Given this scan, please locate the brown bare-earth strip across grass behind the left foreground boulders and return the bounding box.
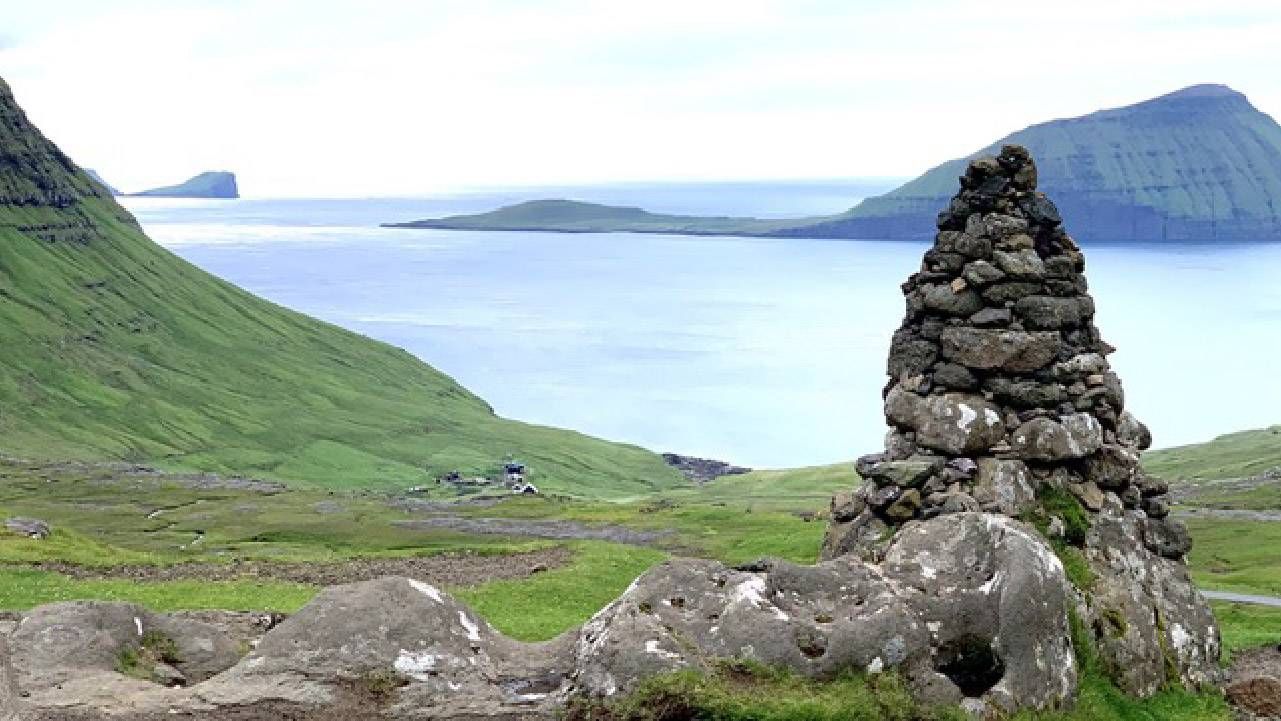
[12,547,573,585]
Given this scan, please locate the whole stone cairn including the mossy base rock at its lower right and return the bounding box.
[822,146,1220,695]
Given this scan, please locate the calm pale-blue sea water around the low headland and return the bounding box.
[127,183,1281,467]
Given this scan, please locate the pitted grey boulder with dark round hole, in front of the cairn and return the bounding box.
[586,514,1076,711]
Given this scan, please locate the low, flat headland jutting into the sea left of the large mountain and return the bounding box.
[384,200,793,236]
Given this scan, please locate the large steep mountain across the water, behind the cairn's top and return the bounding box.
[784,85,1281,241]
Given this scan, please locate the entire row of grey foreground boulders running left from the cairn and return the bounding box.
[2,512,1077,718]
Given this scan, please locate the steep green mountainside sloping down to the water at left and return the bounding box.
[0,81,683,497]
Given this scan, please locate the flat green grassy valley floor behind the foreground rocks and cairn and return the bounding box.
[0,448,1281,718]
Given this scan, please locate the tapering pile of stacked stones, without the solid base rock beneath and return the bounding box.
[824,145,1187,558]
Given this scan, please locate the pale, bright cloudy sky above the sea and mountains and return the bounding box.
[0,0,1281,197]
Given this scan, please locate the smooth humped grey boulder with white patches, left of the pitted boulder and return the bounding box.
[197,576,573,717]
